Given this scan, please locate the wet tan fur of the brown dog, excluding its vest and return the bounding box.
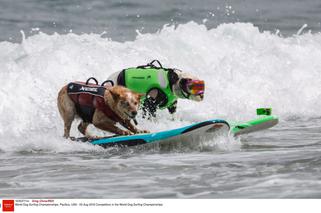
[57,86,148,138]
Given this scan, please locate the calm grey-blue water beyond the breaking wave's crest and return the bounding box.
[0,0,321,41]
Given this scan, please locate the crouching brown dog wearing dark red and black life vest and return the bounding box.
[57,82,148,138]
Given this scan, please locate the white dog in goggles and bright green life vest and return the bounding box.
[108,60,205,117]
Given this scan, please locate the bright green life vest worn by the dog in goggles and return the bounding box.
[124,67,177,109]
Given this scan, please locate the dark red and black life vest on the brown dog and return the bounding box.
[67,82,122,123]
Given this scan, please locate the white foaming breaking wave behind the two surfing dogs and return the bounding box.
[0,22,321,151]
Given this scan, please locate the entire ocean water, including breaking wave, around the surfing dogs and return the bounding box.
[0,0,321,198]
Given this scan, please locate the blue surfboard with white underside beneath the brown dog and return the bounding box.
[89,119,230,148]
